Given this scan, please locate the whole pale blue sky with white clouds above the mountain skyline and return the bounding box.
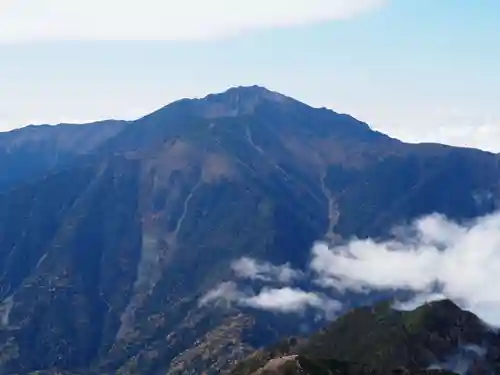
[0,0,500,152]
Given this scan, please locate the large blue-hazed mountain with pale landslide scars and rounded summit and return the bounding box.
[0,86,500,375]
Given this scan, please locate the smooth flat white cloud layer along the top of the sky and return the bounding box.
[0,0,386,42]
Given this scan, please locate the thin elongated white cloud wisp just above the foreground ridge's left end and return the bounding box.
[200,281,342,319]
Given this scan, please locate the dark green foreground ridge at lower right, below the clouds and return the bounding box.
[230,300,500,375]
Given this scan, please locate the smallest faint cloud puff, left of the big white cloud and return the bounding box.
[231,257,303,284]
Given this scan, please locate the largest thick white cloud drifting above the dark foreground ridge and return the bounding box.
[311,213,500,325]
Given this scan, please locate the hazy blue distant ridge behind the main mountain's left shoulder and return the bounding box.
[0,121,127,191]
